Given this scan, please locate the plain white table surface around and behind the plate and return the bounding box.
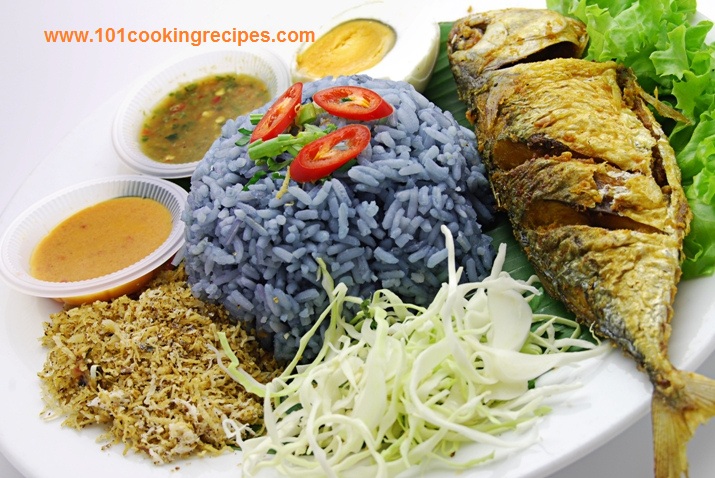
[0,0,715,478]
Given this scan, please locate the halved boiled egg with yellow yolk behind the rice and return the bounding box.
[291,2,439,91]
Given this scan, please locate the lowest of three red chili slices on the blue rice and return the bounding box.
[290,124,370,182]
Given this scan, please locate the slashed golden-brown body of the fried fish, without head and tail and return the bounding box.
[471,59,691,400]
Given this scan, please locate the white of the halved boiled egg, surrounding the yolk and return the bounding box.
[291,2,440,92]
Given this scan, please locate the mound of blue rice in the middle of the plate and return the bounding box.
[184,76,494,360]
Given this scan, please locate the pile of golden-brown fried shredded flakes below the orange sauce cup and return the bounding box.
[39,266,280,464]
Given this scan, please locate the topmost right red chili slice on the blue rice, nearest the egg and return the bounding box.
[313,86,394,121]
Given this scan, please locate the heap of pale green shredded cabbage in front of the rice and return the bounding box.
[215,226,607,477]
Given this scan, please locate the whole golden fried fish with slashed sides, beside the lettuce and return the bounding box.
[448,10,715,478]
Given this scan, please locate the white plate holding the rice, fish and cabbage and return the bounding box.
[0,0,715,478]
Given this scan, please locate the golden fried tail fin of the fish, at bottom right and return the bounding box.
[651,372,715,478]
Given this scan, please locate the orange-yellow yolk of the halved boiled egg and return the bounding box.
[297,20,396,78]
